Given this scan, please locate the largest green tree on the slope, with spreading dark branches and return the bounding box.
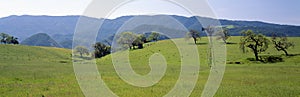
[240,30,269,61]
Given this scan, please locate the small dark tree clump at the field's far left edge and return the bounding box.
[0,33,19,44]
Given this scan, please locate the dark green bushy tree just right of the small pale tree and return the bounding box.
[93,42,111,58]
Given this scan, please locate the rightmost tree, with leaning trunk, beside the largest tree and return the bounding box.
[272,34,295,56]
